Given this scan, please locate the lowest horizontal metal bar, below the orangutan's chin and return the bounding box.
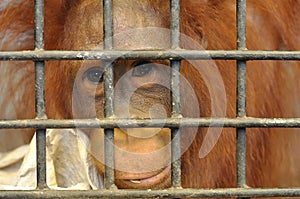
[0,188,300,199]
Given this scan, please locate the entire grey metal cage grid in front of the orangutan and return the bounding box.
[0,0,300,198]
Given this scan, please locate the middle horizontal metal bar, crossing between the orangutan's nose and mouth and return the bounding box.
[0,117,300,129]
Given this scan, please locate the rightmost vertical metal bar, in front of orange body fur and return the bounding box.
[236,0,247,187]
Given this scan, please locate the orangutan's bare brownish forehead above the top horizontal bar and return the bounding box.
[65,0,170,50]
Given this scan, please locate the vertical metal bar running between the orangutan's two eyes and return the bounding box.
[103,0,115,189]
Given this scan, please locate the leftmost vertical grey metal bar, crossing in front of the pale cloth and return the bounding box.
[34,0,47,189]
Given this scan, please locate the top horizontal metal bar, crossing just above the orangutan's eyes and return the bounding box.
[0,50,300,61]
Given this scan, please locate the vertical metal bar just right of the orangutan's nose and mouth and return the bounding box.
[170,0,181,188]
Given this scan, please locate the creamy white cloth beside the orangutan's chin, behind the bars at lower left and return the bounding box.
[0,129,103,190]
